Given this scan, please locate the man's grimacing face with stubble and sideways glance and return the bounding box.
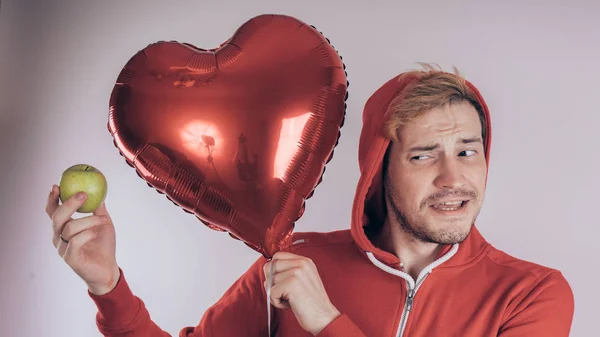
[385,102,487,244]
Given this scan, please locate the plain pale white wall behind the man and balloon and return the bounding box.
[0,0,600,337]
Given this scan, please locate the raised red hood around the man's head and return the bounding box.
[351,74,492,267]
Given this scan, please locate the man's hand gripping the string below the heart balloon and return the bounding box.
[264,252,340,336]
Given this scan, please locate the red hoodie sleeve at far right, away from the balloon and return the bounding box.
[498,271,575,337]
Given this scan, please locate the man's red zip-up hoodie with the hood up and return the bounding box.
[88,72,574,337]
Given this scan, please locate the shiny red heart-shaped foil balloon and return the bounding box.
[108,15,348,257]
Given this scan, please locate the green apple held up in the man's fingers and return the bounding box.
[59,164,108,213]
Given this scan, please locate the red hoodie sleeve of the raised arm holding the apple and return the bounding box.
[88,256,268,337]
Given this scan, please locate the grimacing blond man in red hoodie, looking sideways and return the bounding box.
[47,66,574,337]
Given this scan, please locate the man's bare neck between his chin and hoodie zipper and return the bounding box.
[374,218,443,281]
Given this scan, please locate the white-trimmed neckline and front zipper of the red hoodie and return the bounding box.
[366,243,459,337]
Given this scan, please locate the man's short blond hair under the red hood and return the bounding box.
[384,63,487,141]
